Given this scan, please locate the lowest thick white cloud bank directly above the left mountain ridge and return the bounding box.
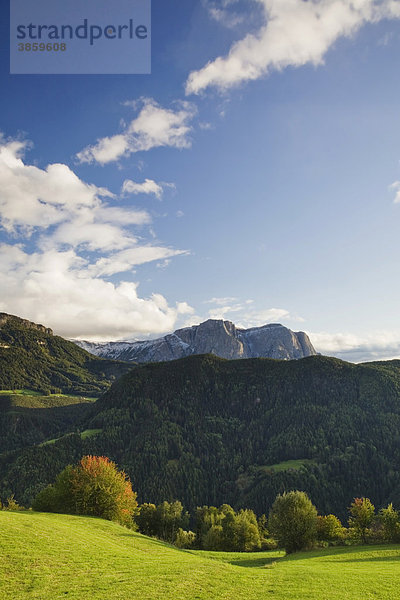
[0,245,191,340]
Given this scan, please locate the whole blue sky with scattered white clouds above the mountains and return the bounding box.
[0,0,400,360]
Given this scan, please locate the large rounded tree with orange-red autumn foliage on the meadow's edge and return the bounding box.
[33,456,137,527]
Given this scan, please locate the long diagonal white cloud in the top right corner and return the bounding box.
[186,0,400,94]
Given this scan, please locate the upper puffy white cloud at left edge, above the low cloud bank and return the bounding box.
[0,138,151,250]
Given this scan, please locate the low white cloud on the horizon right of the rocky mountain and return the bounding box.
[309,331,400,362]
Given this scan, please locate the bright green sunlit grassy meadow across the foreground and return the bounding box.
[0,511,400,600]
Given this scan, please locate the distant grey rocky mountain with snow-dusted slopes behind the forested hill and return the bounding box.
[75,319,317,363]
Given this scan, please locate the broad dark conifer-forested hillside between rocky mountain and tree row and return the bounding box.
[0,355,400,518]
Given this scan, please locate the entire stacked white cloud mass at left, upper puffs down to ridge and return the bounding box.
[0,138,192,340]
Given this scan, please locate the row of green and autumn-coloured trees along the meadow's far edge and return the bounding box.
[8,455,400,553]
